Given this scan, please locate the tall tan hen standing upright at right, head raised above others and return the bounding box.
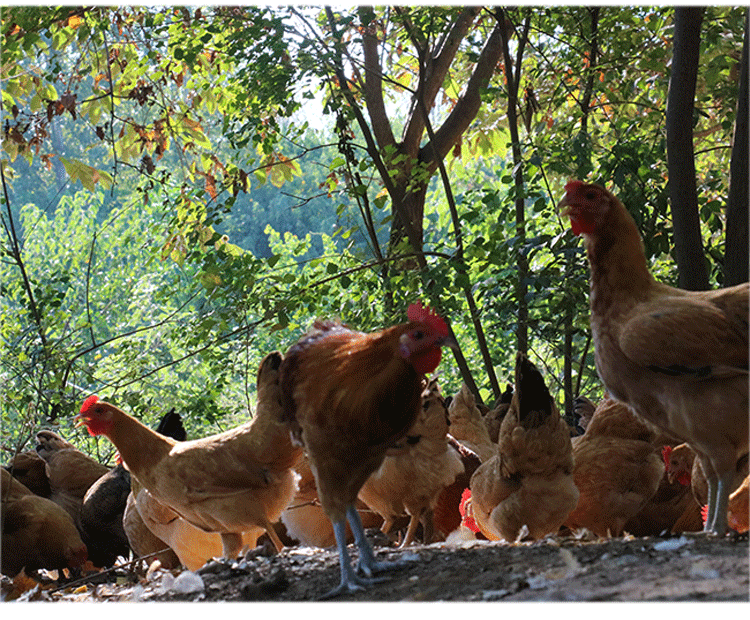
[558,181,748,536]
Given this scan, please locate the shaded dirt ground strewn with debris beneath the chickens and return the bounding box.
[2,531,750,602]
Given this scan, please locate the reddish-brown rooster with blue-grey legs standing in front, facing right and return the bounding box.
[280,304,452,598]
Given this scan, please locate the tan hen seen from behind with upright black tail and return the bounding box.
[470,354,579,542]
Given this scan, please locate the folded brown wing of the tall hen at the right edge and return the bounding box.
[619,285,748,379]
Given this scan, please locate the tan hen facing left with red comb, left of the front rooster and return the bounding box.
[77,353,302,558]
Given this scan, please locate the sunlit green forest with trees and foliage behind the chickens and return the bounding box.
[0,6,748,462]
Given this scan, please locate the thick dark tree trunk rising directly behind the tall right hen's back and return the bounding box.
[666,6,709,291]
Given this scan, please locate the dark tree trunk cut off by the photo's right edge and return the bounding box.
[724,9,750,286]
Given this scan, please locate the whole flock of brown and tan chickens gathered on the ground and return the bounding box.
[0,181,748,598]
